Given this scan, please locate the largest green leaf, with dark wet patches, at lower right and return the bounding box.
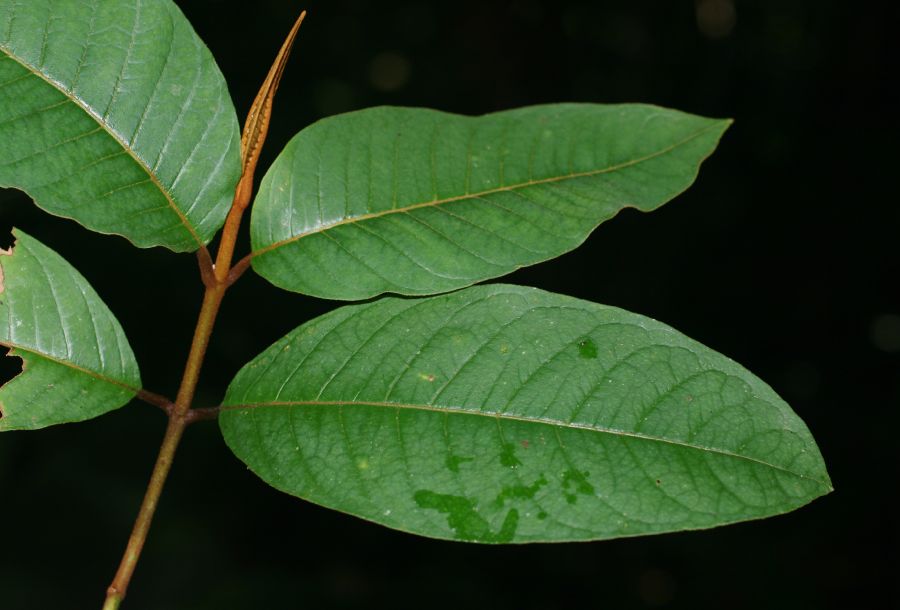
[220,285,831,543]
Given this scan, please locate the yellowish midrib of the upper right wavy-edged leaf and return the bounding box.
[250,122,720,258]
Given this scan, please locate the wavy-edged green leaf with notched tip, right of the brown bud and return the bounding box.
[251,104,730,300]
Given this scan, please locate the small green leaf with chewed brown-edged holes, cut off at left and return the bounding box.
[0,231,141,431]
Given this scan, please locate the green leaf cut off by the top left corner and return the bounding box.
[0,0,240,251]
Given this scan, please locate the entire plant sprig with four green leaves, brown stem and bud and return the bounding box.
[0,0,831,608]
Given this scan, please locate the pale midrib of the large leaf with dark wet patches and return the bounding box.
[221,400,831,489]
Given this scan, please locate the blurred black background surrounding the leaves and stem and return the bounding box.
[0,0,900,610]
